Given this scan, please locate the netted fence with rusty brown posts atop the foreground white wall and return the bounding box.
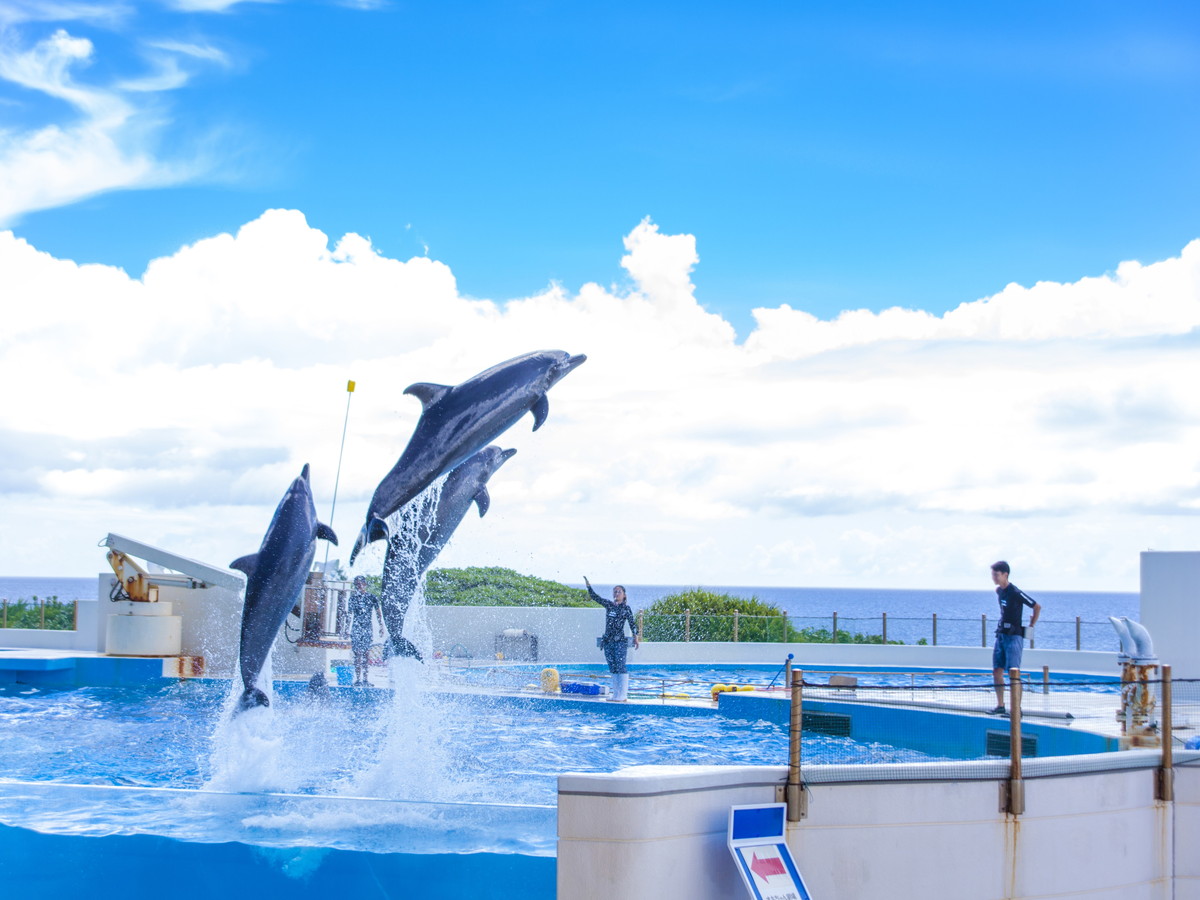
[788,666,1200,821]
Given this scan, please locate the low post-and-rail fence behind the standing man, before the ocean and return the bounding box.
[638,611,1120,650]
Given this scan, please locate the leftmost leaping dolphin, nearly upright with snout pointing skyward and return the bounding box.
[229,463,337,712]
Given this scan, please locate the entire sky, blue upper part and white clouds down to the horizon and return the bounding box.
[0,0,1200,592]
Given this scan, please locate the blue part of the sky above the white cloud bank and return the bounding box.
[9,0,1200,336]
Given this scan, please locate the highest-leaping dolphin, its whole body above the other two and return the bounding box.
[350,350,587,565]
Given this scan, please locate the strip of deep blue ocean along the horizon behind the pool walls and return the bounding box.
[0,577,1140,650]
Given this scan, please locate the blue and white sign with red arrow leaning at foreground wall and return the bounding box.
[728,803,812,900]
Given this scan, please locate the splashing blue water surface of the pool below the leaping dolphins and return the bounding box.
[0,664,960,856]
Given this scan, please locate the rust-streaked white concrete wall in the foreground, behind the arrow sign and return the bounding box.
[558,751,1200,900]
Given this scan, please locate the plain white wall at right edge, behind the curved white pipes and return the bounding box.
[1141,551,1200,678]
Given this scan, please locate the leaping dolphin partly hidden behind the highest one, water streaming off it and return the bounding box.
[379,445,516,660]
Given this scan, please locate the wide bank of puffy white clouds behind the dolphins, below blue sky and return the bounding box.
[0,210,1200,589]
